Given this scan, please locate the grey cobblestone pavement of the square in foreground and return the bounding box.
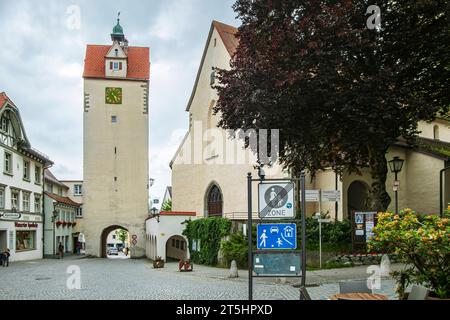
[0,259,395,300]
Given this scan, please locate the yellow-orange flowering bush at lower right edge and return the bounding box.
[369,209,450,299]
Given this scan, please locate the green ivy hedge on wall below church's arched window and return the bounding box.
[183,217,231,266]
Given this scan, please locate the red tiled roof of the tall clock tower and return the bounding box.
[83,45,150,80]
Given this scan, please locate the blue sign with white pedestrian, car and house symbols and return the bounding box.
[256,223,297,250]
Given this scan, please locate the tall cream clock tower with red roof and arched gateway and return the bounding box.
[80,18,150,258]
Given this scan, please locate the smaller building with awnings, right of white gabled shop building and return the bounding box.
[44,169,81,258]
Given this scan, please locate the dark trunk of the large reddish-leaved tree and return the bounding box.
[369,149,391,212]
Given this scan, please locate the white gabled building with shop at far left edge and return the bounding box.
[0,92,52,261]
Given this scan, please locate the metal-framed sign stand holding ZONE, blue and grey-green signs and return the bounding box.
[247,172,308,301]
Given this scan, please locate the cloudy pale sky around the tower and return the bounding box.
[0,0,239,204]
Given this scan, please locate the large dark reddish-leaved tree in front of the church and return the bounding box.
[214,0,450,211]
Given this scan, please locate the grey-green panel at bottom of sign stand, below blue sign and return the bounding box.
[253,252,302,277]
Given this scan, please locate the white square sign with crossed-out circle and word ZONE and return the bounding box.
[258,182,295,219]
